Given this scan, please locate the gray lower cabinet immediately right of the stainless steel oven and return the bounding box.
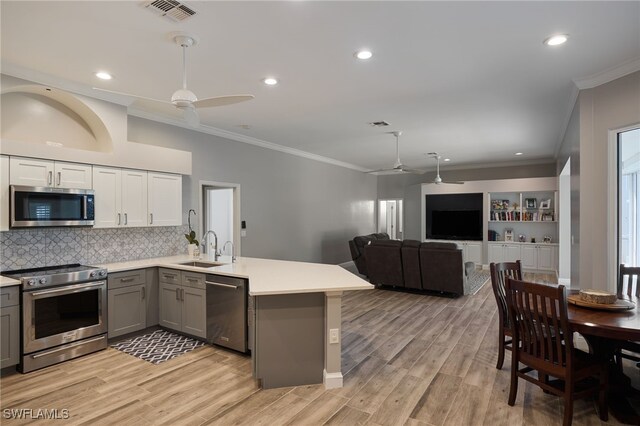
[107,269,148,338]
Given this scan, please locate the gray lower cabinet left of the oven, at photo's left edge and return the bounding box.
[0,286,20,368]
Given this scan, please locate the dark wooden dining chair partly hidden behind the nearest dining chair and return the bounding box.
[489,260,522,370]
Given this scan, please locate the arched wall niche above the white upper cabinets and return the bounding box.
[0,85,113,153]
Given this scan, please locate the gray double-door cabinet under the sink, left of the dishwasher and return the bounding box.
[159,268,207,339]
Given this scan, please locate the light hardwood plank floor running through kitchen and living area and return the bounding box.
[0,275,638,426]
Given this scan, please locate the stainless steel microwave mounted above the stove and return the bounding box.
[10,185,95,228]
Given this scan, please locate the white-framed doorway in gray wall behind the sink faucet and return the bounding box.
[200,182,241,256]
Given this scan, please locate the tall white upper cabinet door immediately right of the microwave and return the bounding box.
[93,166,123,228]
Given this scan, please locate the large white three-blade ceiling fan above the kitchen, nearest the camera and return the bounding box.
[94,32,254,125]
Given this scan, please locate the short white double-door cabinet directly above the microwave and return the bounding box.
[9,157,92,189]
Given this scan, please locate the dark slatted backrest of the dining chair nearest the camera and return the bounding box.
[505,278,573,377]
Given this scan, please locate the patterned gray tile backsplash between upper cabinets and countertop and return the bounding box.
[0,225,188,271]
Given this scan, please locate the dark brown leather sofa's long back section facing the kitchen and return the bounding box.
[364,240,475,296]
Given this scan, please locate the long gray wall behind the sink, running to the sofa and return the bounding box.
[128,117,377,263]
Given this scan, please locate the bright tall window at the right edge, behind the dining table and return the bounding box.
[618,128,640,266]
